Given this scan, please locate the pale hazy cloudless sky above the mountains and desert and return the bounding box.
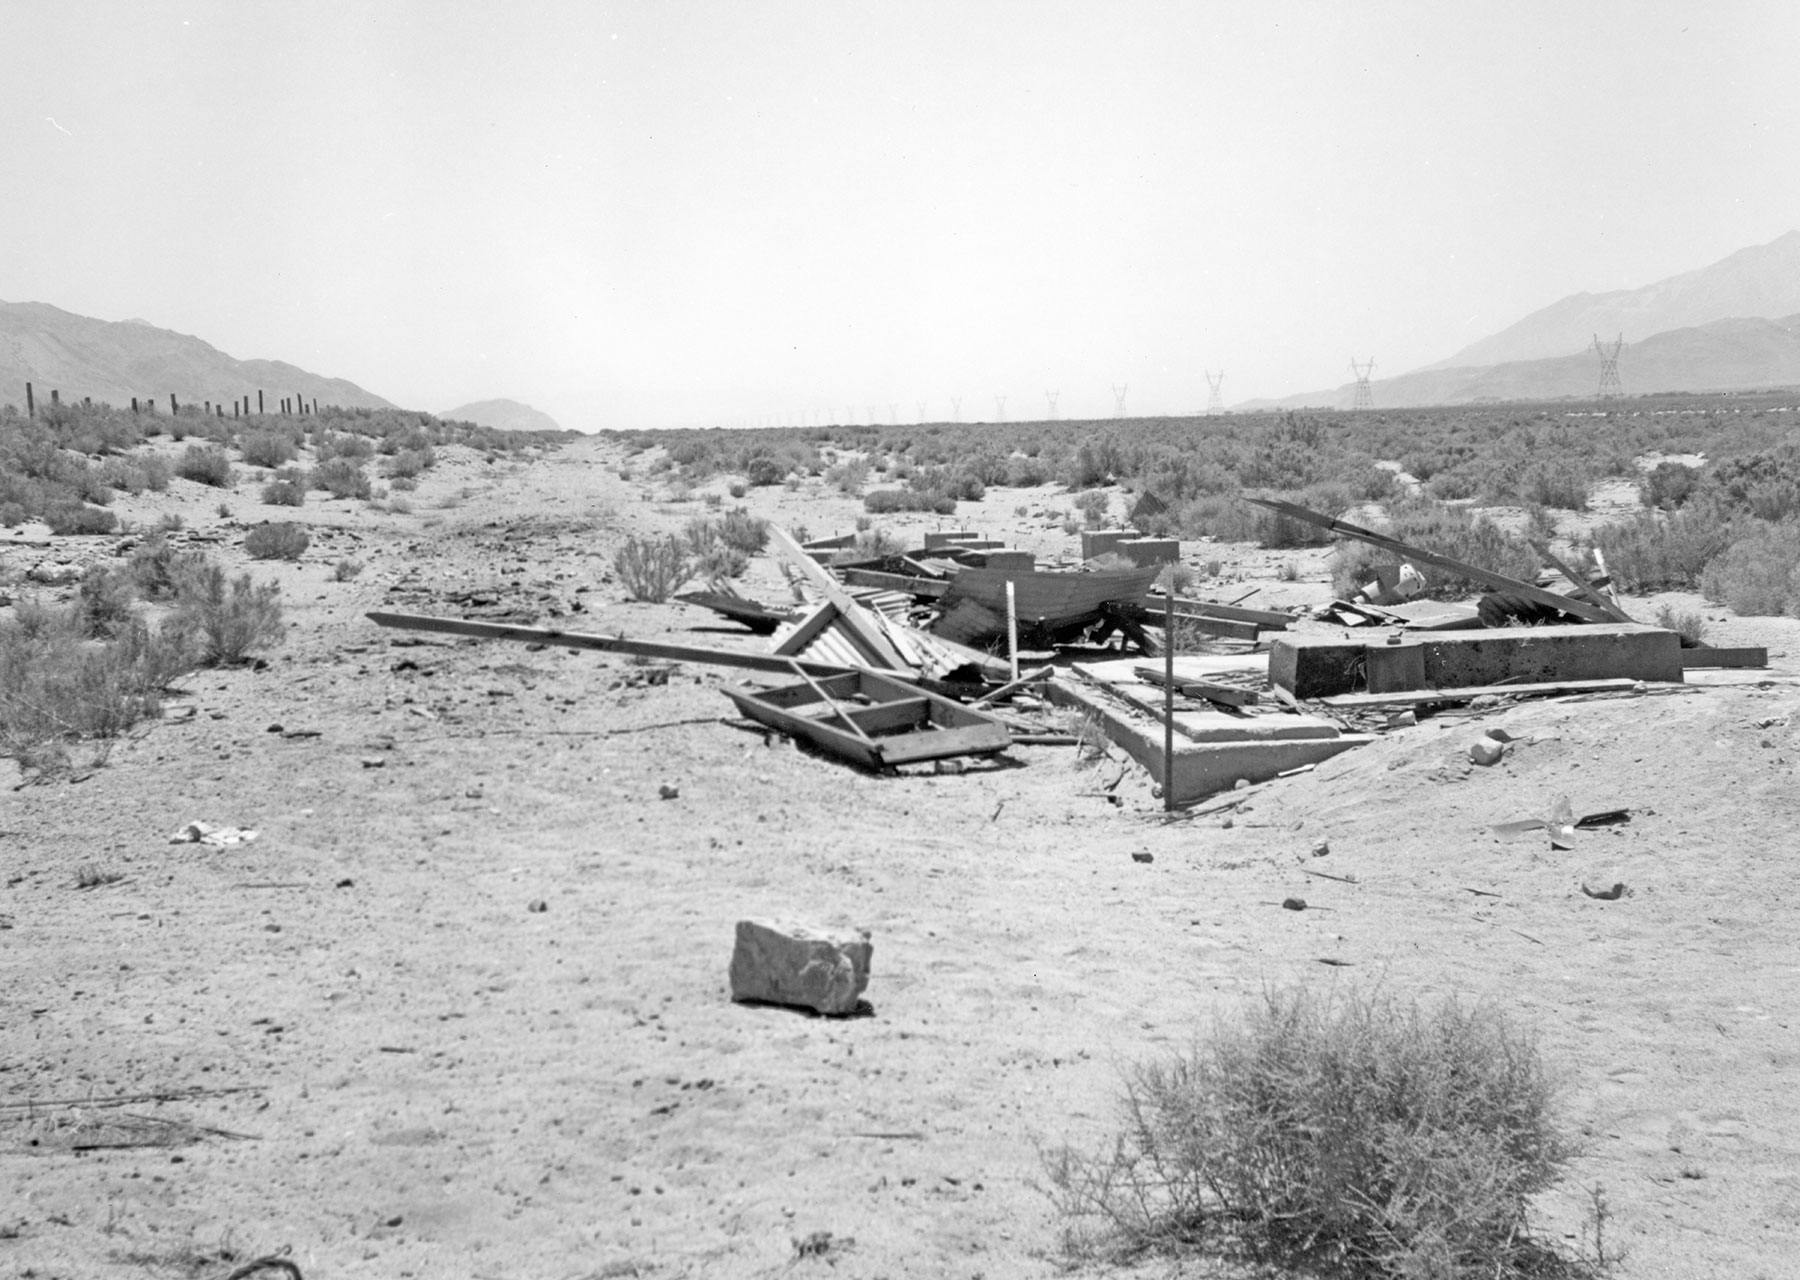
[0,0,1800,430]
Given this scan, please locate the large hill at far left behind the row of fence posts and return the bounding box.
[0,302,394,410]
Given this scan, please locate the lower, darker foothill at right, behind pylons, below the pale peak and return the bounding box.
[1237,313,1800,409]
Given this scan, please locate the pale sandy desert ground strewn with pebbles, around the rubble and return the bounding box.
[0,439,1800,1280]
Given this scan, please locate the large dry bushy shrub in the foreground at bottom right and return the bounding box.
[1046,990,1582,1280]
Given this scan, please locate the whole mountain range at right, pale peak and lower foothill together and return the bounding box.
[1235,230,1800,409]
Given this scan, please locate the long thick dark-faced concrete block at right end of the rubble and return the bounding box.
[1269,623,1681,699]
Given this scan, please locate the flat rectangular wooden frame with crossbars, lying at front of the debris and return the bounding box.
[722,672,1012,769]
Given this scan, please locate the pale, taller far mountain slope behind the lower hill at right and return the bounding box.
[1427,230,1800,369]
